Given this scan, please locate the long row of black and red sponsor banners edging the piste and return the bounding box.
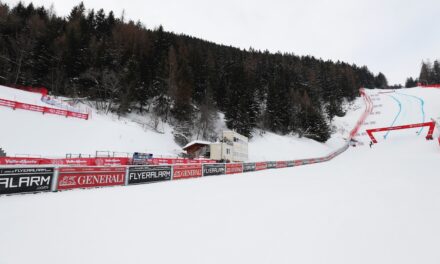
[0,144,348,195]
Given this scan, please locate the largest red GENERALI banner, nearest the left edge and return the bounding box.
[58,167,125,190]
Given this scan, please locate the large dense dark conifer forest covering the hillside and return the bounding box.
[0,2,387,144]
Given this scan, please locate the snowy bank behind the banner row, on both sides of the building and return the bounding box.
[0,86,363,161]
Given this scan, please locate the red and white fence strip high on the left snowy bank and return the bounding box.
[0,98,89,120]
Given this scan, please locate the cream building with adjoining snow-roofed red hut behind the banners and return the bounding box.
[183,131,248,162]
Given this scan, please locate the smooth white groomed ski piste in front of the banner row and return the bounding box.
[0,88,440,264]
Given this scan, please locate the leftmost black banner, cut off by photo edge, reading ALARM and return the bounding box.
[0,167,54,194]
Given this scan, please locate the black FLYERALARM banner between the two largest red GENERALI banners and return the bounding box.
[128,166,171,184]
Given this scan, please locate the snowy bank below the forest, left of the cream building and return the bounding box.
[0,86,181,157]
